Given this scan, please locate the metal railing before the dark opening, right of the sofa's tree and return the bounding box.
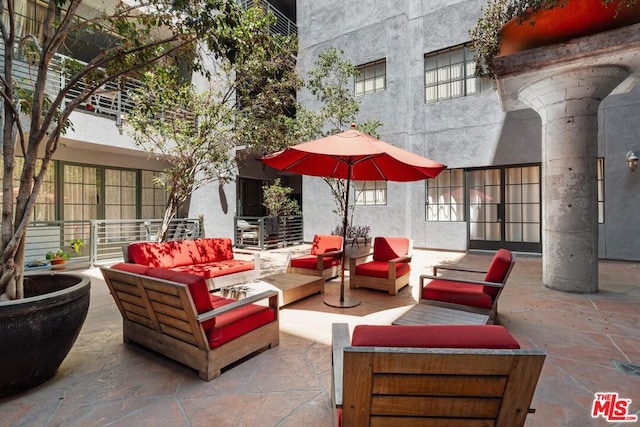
[234,215,304,250]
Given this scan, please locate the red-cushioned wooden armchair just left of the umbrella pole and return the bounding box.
[287,234,342,280]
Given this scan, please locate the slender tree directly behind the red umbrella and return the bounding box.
[294,48,382,224]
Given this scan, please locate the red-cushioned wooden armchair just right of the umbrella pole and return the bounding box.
[349,237,413,295]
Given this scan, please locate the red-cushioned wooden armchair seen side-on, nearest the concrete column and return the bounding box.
[420,249,516,323]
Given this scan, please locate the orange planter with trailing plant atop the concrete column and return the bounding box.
[470,0,640,77]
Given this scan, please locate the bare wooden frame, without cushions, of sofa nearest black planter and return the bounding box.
[100,268,279,381]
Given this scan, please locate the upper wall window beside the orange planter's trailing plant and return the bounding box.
[424,45,481,103]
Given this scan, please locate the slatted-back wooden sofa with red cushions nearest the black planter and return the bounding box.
[101,263,280,381]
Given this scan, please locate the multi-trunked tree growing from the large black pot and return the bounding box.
[0,0,276,300]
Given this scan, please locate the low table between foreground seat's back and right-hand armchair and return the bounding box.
[393,304,489,325]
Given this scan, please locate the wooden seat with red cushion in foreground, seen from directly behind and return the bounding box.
[331,323,545,427]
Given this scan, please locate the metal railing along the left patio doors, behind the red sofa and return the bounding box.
[25,218,204,268]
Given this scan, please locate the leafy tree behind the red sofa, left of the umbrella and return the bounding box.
[127,9,298,241]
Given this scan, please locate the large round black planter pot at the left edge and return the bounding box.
[0,273,91,396]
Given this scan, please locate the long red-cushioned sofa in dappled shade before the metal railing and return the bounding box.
[125,238,260,290]
